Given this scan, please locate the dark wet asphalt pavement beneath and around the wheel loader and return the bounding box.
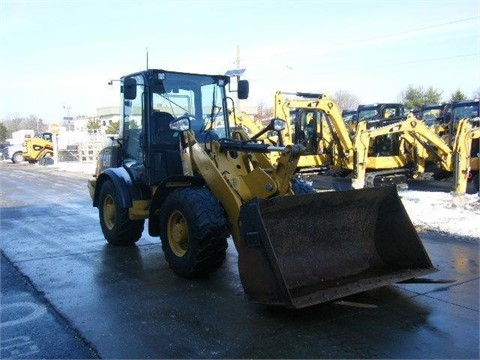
[0,162,479,359]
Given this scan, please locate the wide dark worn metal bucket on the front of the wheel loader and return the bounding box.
[238,187,437,308]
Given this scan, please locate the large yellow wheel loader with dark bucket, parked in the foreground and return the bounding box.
[88,69,436,308]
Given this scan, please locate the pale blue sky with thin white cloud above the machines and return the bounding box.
[0,0,480,122]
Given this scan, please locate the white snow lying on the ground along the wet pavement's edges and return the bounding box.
[52,163,480,241]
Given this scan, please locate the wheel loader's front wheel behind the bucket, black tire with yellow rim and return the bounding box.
[159,187,228,278]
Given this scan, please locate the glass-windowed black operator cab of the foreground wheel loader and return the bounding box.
[120,70,248,186]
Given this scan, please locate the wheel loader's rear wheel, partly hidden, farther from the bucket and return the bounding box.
[98,180,145,246]
